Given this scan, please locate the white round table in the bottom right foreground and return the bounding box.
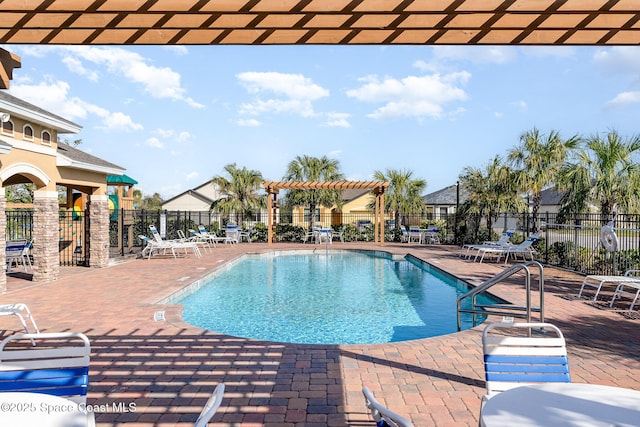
[480,383,640,427]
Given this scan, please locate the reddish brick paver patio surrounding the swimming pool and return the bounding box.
[0,243,640,427]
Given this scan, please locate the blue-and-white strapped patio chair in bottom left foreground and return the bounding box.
[0,332,91,404]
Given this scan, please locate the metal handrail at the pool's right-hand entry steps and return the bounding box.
[457,261,544,330]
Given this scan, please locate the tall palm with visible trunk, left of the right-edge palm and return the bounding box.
[507,128,580,230]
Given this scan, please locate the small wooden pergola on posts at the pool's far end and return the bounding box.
[262,181,389,246]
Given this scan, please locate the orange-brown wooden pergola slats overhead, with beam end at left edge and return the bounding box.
[0,0,640,89]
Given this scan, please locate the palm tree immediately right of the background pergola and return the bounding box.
[373,169,427,229]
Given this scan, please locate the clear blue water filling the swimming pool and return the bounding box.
[176,251,498,344]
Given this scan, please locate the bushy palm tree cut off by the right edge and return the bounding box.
[557,130,640,219]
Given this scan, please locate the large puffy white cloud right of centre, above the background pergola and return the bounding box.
[347,71,471,119]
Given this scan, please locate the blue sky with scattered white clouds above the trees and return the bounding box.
[4,45,640,199]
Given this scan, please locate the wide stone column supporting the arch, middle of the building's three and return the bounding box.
[32,190,60,282]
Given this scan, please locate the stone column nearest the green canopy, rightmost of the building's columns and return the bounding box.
[85,194,109,268]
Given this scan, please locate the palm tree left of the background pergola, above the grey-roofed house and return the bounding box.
[211,163,266,226]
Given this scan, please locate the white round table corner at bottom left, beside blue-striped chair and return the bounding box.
[0,392,95,427]
